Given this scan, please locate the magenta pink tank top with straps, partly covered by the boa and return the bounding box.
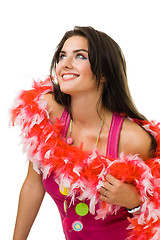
[43,110,131,240]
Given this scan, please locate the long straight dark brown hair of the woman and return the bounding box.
[50,27,146,120]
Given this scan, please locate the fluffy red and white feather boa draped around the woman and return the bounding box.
[11,78,160,240]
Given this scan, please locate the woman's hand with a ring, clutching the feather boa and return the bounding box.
[99,174,141,209]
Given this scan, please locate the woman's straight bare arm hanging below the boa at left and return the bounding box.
[13,162,45,240]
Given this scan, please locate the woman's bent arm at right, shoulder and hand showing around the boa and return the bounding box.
[99,120,155,209]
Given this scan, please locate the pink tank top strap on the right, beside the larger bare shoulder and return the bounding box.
[106,112,125,158]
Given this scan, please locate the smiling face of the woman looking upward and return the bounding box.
[56,36,97,96]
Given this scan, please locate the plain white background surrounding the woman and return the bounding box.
[0,0,160,240]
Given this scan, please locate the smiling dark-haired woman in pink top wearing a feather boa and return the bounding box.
[12,27,160,240]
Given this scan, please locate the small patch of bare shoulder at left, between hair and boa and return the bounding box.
[43,93,64,121]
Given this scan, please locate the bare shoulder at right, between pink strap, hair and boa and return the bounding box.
[119,119,154,160]
